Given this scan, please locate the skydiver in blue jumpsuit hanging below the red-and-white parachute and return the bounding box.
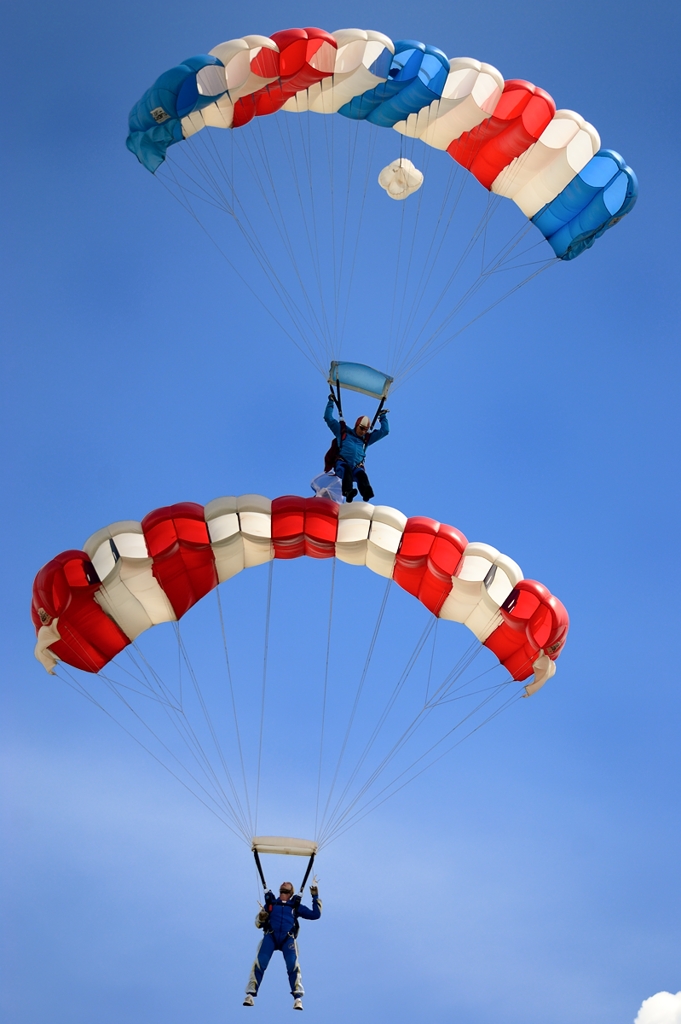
[244,882,322,1010]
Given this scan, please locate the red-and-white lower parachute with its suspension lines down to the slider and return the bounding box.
[32,495,568,851]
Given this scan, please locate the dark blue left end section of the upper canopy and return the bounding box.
[125,54,226,172]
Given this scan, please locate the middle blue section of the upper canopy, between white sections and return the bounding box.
[339,39,450,128]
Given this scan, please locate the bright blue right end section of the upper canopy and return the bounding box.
[531,150,638,259]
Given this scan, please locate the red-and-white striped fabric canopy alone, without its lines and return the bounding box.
[32,495,569,693]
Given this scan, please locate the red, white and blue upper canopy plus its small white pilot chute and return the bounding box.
[127,28,638,260]
